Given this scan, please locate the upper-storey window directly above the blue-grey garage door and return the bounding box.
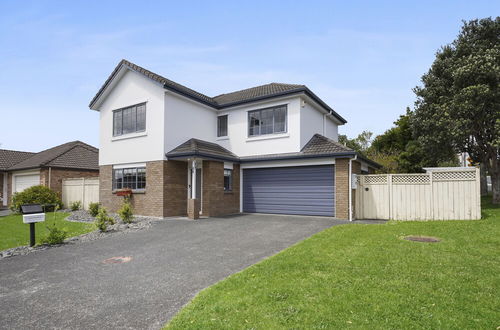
[248,105,287,136]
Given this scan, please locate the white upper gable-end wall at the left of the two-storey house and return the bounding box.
[97,70,165,165]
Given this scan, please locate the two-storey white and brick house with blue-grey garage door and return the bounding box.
[89,60,378,219]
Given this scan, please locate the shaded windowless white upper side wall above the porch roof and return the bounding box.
[164,91,217,153]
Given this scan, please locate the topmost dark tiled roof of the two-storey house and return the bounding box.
[89,60,347,124]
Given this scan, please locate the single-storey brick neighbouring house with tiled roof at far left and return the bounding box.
[0,141,99,207]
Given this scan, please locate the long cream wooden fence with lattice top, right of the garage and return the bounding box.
[355,168,481,220]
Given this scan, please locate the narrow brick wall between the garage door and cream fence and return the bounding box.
[335,158,361,219]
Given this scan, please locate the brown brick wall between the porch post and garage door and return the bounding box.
[202,160,240,216]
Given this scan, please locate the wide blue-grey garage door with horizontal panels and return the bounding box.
[243,165,335,216]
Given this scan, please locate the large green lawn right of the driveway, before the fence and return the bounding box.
[166,200,500,329]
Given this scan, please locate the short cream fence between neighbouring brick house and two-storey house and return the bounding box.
[62,178,99,210]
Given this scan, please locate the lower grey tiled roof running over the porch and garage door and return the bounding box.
[166,134,380,168]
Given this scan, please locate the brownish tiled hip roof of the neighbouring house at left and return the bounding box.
[8,141,99,171]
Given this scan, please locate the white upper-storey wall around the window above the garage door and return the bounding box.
[216,96,300,156]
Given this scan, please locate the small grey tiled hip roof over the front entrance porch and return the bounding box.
[167,139,238,161]
